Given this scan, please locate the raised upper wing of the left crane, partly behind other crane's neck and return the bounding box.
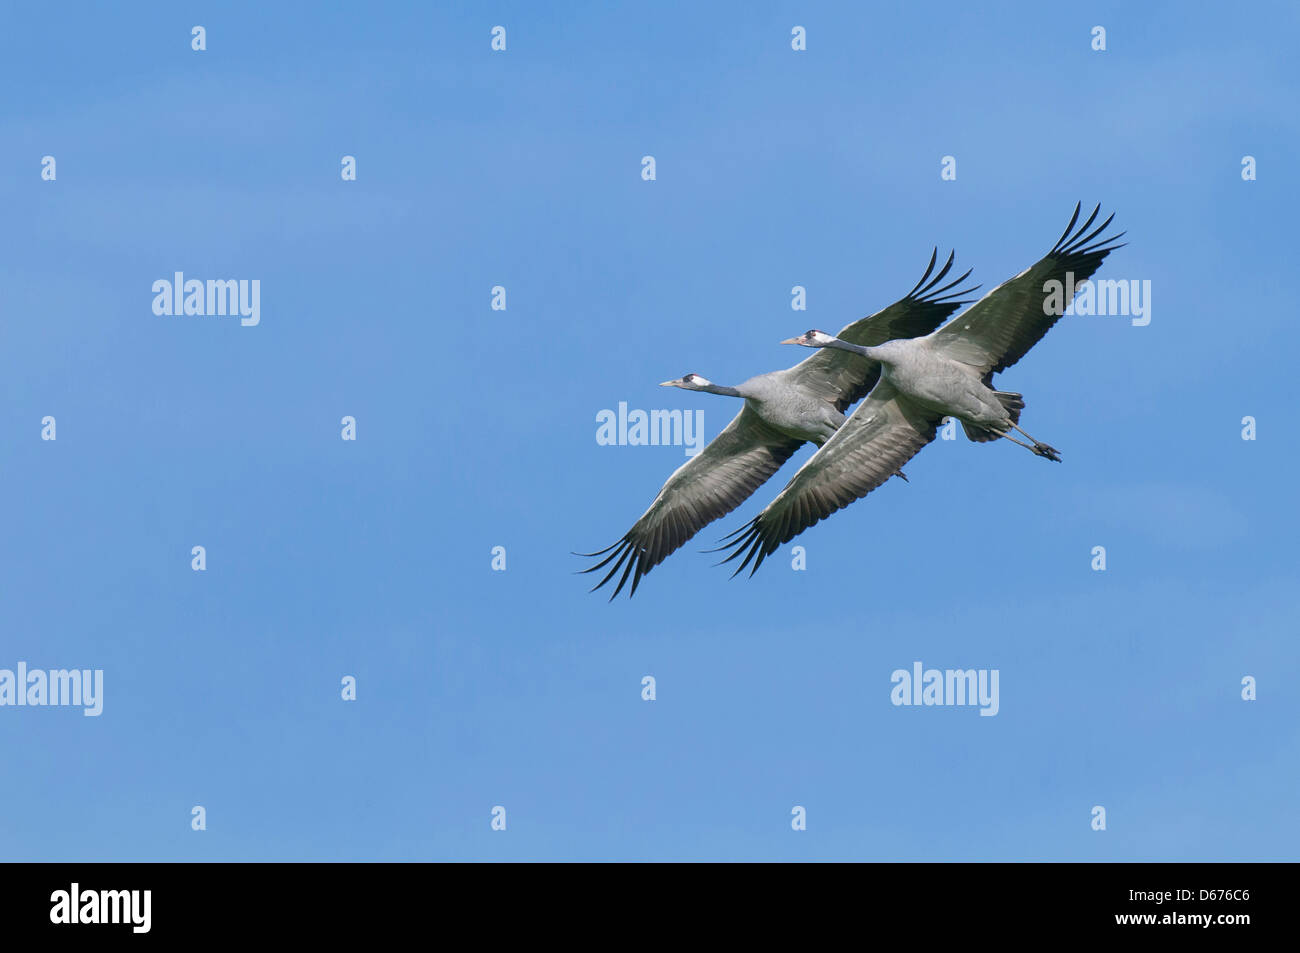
[787,248,979,413]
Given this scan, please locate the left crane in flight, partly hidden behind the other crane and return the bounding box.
[575,247,979,602]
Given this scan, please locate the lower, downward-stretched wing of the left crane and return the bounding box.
[579,404,803,601]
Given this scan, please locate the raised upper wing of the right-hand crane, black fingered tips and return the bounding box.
[931,205,1125,376]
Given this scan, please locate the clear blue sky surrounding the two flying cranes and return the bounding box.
[0,3,1300,861]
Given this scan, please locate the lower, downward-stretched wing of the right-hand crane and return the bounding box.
[714,381,943,576]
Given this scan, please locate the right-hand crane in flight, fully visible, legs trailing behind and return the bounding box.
[709,204,1126,577]
